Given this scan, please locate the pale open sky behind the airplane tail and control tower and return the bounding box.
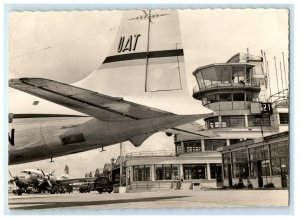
[8,9,289,177]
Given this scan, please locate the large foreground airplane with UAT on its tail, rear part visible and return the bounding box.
[8,10,215,164]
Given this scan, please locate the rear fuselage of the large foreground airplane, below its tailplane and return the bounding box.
[9,114,199,164]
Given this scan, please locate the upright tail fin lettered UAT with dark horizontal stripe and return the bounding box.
[75,10,206,114]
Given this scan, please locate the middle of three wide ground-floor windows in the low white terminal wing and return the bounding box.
[155,164,179,180]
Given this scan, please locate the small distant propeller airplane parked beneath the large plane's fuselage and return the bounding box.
[9,165,75,195]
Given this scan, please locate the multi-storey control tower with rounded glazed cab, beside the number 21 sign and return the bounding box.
[175,53,288,187]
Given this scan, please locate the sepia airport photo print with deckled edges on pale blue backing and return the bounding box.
[5,6,292,214]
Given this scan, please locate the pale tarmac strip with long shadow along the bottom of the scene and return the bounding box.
[8,190,289,212]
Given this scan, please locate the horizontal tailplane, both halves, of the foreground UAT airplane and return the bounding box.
[9,78,215,137]
